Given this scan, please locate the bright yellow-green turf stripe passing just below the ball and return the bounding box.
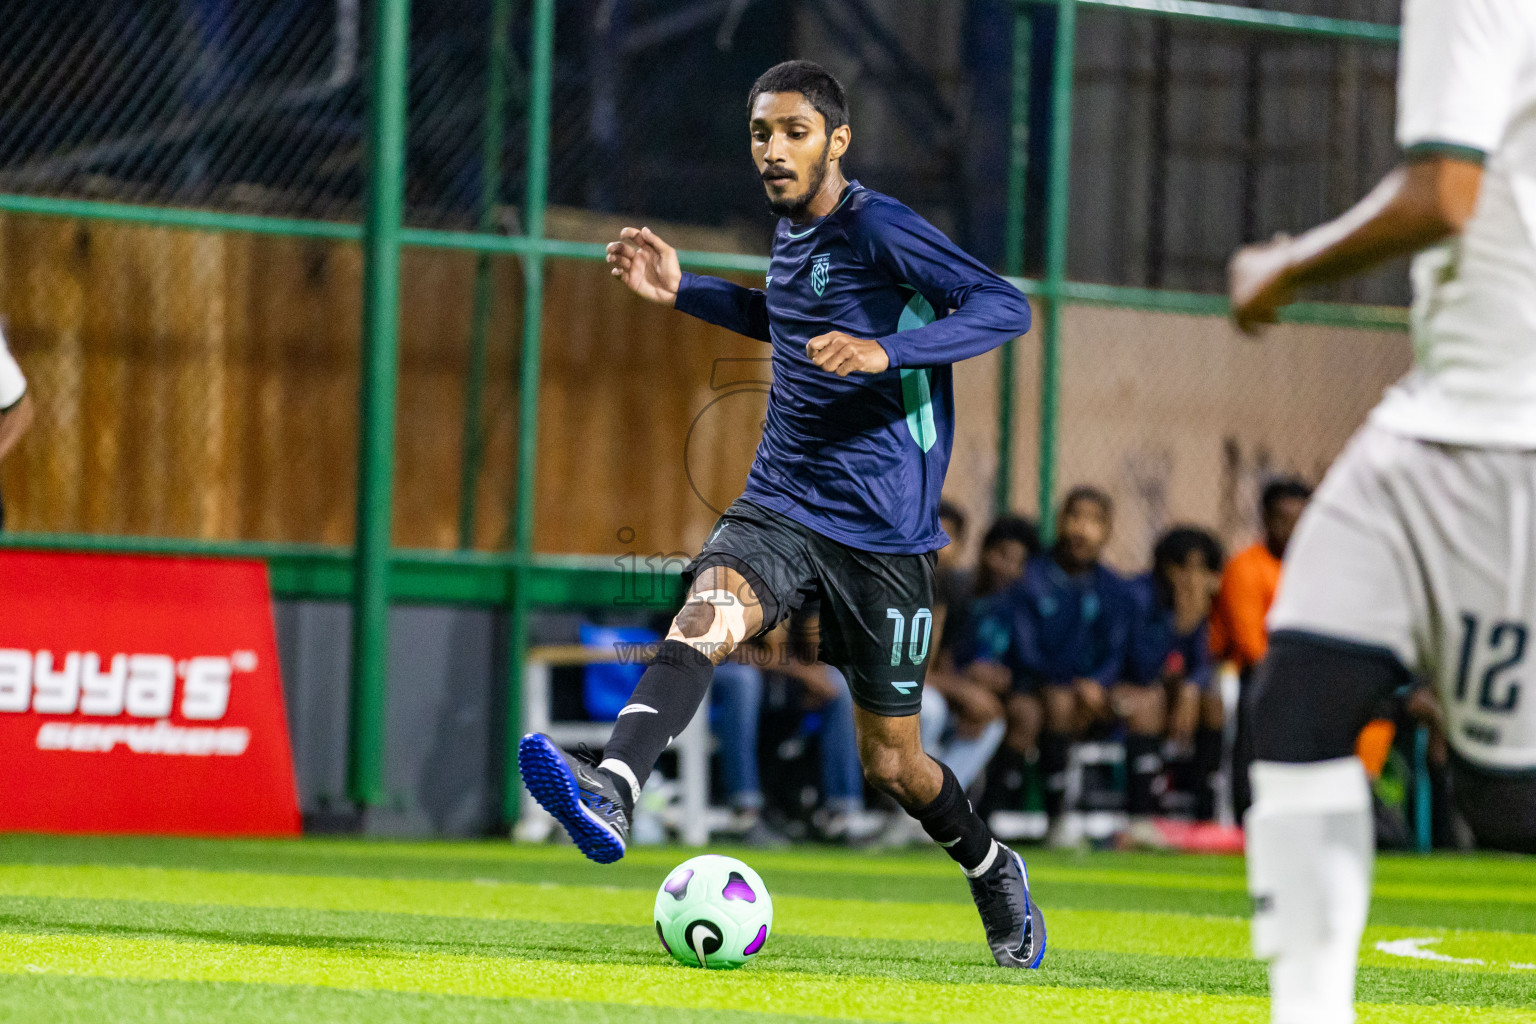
[0,935,1530,1024]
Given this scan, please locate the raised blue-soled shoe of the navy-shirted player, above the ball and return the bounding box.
[518,732,630,864]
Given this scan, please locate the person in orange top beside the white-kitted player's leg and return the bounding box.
[1210,477,1312,821]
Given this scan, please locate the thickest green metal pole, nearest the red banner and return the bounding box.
[347,0,410,806]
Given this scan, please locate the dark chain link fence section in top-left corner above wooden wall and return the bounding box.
[0,0,364,218]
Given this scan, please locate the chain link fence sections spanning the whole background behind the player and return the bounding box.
[0,0,1407,568]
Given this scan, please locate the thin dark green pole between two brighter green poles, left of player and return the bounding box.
[459,0,511,550]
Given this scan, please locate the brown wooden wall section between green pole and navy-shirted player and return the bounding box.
[536,263,768,554]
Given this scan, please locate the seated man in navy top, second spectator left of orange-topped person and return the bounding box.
[966,487,1148,847]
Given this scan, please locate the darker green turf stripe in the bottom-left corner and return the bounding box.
[0,973,854,1024]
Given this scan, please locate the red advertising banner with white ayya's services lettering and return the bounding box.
[0,551,300,835]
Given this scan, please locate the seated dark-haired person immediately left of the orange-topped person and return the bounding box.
[1126,527,1226,821]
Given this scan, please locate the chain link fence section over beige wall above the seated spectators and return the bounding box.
[1015,306,1410,571]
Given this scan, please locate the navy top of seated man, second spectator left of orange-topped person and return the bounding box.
[955,554,1135,686]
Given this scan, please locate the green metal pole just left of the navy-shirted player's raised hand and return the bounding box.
[501,0,554,824]
